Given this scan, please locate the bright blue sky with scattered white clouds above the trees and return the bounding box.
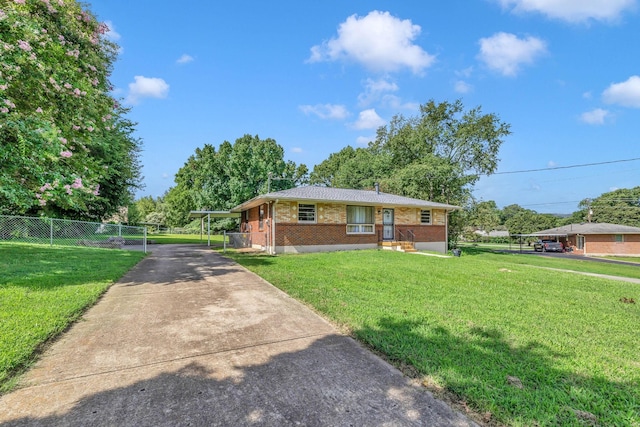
[87,0,640,213]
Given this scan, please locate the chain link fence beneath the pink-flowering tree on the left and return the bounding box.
[0,215,147,252]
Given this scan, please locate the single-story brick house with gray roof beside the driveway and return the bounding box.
[231,187,459,253]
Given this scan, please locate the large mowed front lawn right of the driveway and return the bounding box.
[232,251,640,426]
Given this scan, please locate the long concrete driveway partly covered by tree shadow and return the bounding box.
[0,245,474,426]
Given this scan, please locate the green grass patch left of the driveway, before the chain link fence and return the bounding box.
[0,242,145,392]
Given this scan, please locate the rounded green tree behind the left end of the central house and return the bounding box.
[164,135,308,226]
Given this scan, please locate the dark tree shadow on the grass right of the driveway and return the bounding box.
[353,318,640,426]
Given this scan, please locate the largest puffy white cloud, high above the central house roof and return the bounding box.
[308,10,435,74]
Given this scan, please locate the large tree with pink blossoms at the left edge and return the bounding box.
[0,0,140,219]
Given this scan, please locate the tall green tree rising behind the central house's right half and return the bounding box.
[311,100,510,204]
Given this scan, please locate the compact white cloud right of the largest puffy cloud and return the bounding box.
[478,32,547,76]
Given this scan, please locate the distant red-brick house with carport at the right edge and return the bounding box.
[535,222,640,256]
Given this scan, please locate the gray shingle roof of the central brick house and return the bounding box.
[231,186,460,211]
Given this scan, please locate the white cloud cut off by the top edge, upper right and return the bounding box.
[498,0,636,23]
